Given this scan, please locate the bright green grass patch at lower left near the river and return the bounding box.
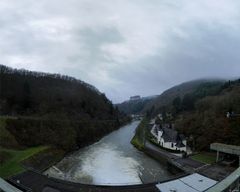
[0,146,48,178]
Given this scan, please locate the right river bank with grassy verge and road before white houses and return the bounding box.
[131,119,235,181]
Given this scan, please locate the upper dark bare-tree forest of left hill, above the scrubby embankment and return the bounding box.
[0,65,118,120]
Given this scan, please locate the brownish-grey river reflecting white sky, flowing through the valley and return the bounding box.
[45,121,171,185]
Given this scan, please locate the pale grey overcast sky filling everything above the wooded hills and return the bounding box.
[0,0,240,103]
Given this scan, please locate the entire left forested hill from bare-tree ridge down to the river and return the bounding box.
[0,65,126,150]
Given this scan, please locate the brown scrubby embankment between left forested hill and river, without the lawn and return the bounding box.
[4,117,127,151]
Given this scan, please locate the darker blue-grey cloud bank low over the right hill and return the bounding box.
[107,23,240,101]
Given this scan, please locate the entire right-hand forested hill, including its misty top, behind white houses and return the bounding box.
[144,79,240,150]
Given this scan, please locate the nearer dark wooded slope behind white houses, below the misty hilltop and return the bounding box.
[172,79,240,150]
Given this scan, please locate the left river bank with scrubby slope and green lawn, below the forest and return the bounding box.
[0,116,129,178]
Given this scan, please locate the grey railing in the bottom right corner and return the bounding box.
[206,167,240,192]
